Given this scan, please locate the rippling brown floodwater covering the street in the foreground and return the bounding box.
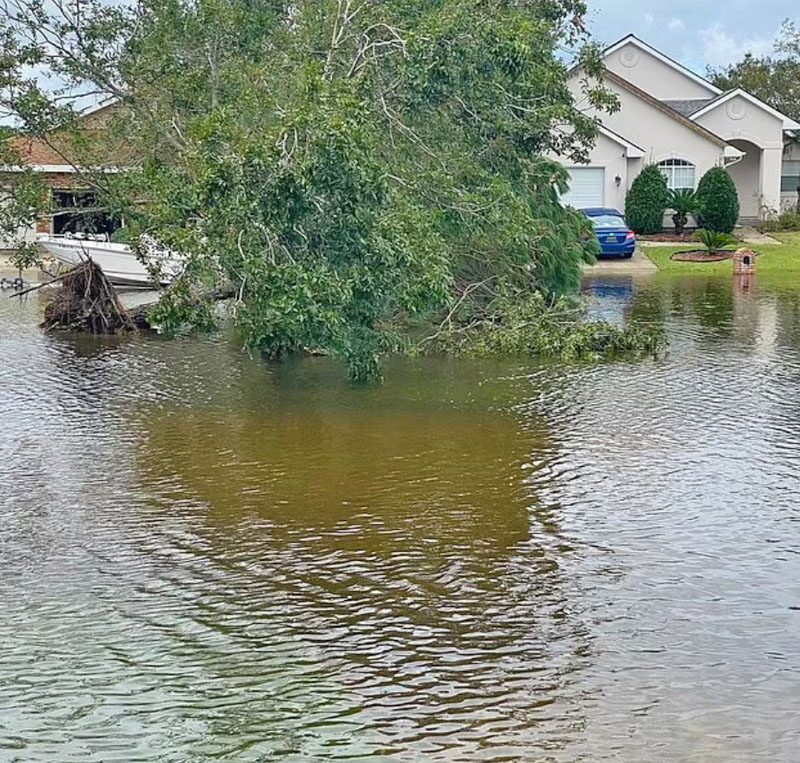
[0,268,800,763]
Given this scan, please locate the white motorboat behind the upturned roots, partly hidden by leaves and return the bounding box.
[36,234,183,286]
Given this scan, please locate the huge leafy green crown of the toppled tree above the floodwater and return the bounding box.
[0,0,617,379]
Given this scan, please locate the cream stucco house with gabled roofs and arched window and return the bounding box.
[563,35,800,222]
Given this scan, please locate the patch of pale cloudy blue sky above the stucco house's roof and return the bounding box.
[587,0,800,74]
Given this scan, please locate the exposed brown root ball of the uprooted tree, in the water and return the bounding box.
[42,259,137,334]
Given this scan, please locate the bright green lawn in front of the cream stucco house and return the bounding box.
[643,233,800,289]
